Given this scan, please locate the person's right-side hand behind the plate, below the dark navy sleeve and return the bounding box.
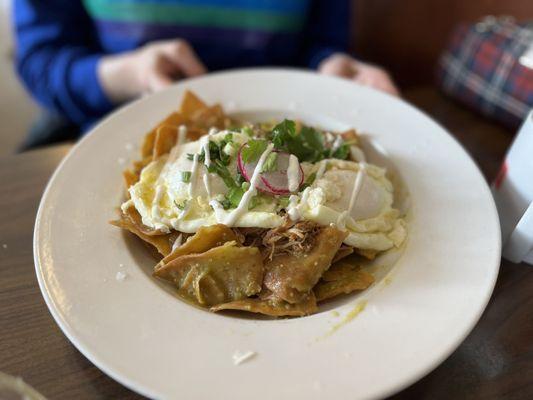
[318,53,400,96]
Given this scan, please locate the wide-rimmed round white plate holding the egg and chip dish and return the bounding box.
[34,70,500,400]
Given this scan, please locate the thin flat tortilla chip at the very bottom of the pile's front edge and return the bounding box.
[210,292,318,317]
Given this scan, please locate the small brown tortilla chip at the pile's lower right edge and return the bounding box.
[313,261,374,301]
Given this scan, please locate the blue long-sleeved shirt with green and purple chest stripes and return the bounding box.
[14,0,350,127]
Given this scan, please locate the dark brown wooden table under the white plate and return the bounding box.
[0,89,533,399]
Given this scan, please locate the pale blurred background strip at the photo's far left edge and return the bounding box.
[0,0,37,157]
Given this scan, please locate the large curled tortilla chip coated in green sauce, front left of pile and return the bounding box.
[154,242,263,306]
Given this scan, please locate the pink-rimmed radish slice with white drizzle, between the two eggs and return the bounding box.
[237,144,304,195]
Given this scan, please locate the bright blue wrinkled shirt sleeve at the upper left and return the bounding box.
[13,0,112,124]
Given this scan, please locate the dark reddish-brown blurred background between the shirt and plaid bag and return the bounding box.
[352,0,533,89]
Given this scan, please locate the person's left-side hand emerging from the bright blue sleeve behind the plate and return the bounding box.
[98,39,207,103]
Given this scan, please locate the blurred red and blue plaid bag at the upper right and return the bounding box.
[437,17,533,128]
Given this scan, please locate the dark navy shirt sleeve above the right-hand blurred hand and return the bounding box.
[304,0,351,69]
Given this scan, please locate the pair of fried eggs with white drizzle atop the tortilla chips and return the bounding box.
[123,131,406,251]
